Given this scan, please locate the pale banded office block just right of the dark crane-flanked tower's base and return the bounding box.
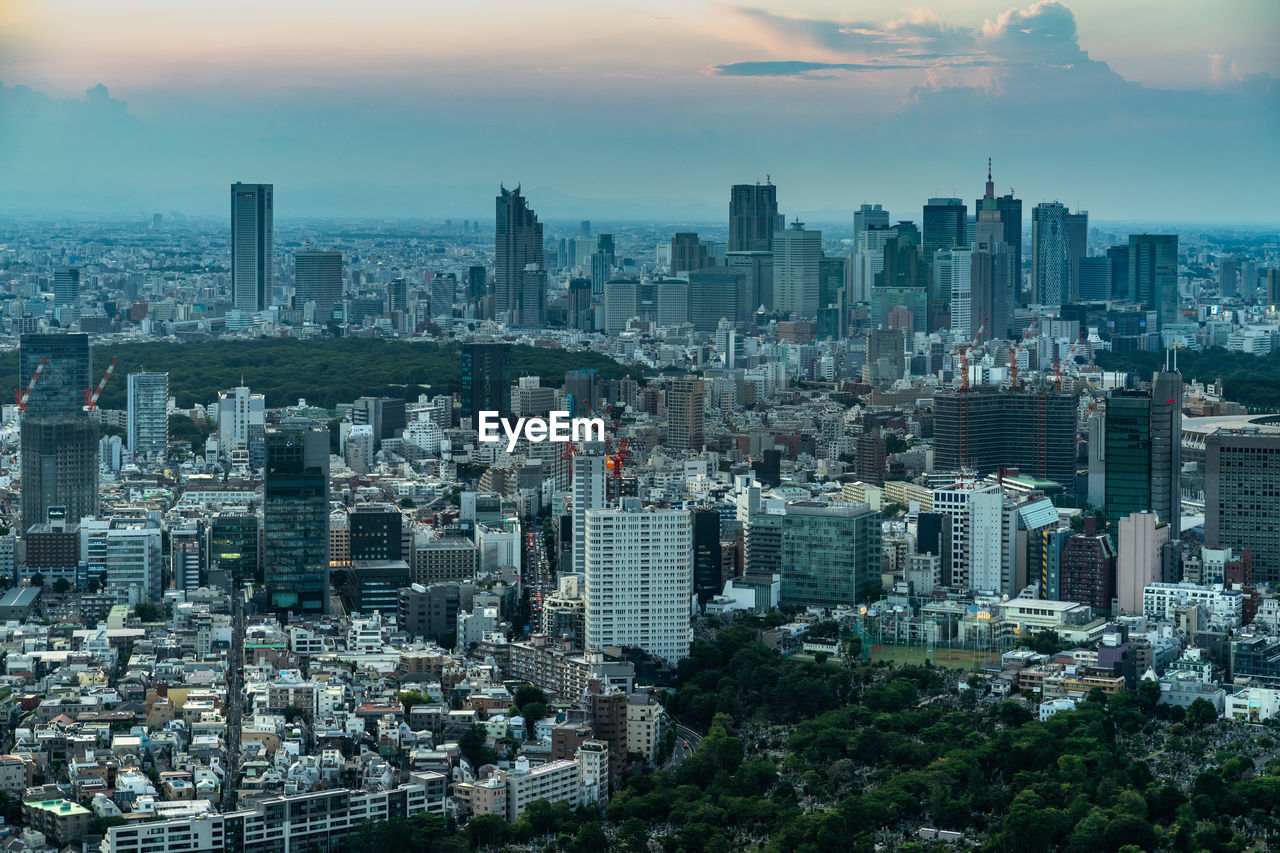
[79,519,164,607]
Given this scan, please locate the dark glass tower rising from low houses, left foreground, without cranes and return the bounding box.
[262,424,329,615]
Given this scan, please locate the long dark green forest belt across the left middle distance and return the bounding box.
[0,338,640,409]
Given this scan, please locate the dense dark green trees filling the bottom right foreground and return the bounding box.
[337,620,1280,853]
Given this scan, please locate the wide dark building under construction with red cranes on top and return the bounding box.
[933,387,1078,494]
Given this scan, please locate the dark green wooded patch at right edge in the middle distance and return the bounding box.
[1094,347,1280,411]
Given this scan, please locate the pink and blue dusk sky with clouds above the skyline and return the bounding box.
[0,0,1280,225]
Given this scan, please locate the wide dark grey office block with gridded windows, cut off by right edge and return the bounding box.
[1204,427,1280,585]
